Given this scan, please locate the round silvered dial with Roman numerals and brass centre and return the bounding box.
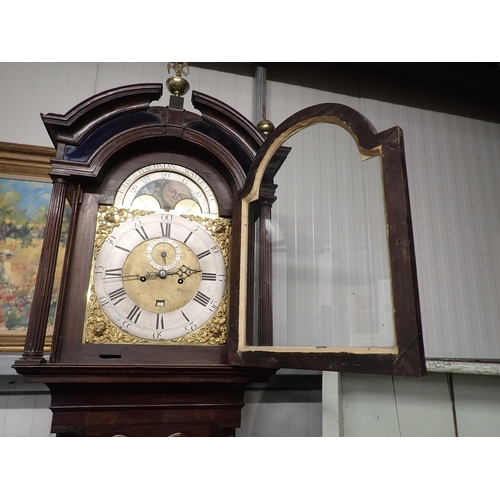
[94,213,226,340]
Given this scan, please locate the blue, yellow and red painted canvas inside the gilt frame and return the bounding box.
[0,176,67,351]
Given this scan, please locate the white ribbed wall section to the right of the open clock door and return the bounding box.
[396,104,500,358]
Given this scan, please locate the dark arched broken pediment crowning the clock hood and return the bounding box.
[42,84,270,192]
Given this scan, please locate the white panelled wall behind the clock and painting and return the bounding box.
[0,63,500,436]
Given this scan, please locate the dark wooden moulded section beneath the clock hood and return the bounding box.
[14,364,275,437]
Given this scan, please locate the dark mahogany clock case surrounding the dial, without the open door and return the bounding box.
[10,84,286,436]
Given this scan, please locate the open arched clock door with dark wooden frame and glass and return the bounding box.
[230,104,425,376]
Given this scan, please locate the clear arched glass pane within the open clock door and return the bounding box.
[270,123,395,347]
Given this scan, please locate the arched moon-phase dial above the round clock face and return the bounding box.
[115,163,219,216]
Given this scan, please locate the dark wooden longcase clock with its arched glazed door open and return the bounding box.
[15,76,425,436]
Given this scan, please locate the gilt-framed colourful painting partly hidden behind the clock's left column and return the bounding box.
[0,142,62,352]
